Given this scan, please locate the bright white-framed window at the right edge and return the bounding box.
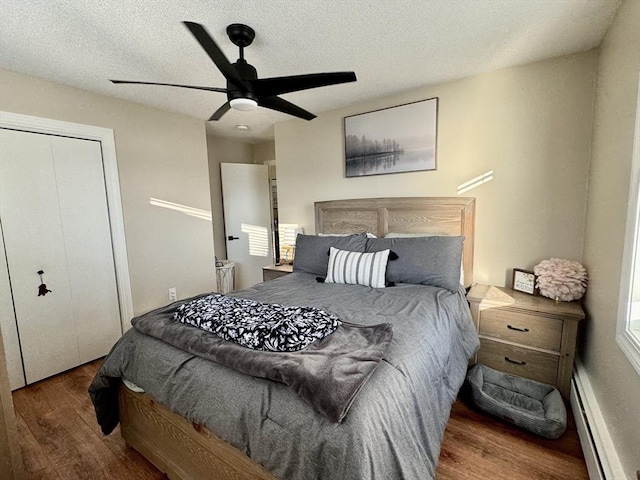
[616,76,640,374]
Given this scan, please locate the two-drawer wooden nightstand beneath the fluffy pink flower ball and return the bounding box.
[467,285,584,401]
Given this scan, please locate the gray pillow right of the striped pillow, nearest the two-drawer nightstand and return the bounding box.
[366,236,463,292]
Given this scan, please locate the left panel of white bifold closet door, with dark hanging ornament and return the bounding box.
[0,130,78,383]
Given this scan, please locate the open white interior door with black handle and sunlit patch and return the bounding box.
[220,163,273,289]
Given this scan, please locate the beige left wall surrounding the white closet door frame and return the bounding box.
[0,70,215,314]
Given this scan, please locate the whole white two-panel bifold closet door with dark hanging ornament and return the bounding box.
[0,130,121,383]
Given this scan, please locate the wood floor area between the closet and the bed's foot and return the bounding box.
[13,360,166,480]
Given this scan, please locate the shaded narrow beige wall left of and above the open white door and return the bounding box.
[207,134,253,260]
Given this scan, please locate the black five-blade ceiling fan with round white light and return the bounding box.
[110,22,356,121]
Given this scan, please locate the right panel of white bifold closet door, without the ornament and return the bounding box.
[51,137,122,363]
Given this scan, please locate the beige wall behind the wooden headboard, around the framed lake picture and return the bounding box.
[275,51,597,285]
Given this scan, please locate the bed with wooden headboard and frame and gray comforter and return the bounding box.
[90,197,478,480]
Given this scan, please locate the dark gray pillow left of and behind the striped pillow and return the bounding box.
[293,233,368,277]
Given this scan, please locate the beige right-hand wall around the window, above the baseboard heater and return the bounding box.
[581,0,640,478]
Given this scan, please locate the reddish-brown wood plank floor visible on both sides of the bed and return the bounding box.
[13,360,588,480]
